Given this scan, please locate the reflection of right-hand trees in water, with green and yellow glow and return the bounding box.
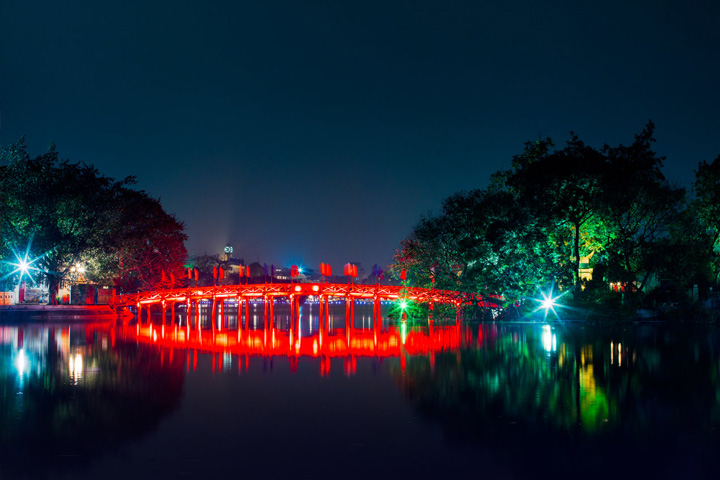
[392,324,720,477]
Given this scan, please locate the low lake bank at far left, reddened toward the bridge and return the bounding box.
[0,305,131,323]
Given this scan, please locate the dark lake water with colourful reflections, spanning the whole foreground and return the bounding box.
[0,312,720,479]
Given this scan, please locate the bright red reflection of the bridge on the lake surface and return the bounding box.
[117,309,462,375]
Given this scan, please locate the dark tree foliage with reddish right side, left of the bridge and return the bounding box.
[0,139,186,298]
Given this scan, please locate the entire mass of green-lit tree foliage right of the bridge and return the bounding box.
[391,122,720,303]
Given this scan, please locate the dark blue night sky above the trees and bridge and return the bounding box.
[0,0,720,271]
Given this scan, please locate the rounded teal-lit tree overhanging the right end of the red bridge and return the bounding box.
[391,189,565,300]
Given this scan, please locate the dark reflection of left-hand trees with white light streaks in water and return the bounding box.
[0,322,184,478]
